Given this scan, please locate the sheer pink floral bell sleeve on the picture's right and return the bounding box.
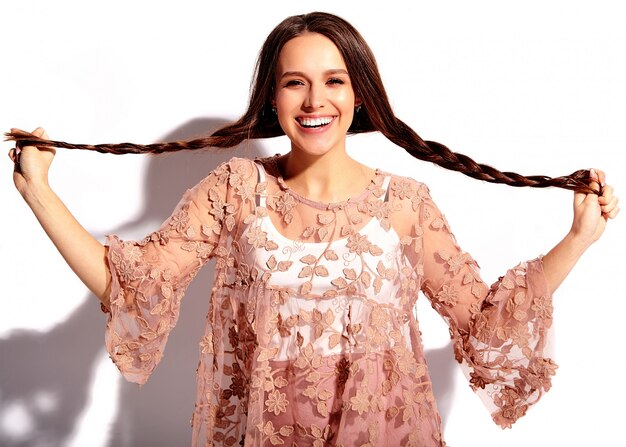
[415,187,557,428]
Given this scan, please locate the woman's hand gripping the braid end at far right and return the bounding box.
[570,169,619,245]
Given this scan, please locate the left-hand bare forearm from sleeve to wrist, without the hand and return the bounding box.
[23,184,111,305]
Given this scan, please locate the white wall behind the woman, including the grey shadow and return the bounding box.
[0,0,626,447]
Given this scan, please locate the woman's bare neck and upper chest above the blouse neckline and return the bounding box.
[279,150,374,203]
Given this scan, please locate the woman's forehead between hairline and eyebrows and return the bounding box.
[276,33,346,75]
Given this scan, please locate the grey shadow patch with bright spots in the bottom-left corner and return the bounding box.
[0,295,103,447]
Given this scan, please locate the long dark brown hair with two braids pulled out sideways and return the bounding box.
[6,12,598,193]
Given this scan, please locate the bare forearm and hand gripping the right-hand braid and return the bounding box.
[543,170,619,293]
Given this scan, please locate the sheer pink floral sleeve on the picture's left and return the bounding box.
[103,161,236,384]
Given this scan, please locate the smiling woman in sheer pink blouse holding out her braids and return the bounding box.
[9,13,619,446]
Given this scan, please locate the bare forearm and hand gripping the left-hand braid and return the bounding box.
[9,128,111,307]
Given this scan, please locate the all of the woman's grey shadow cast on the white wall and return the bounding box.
[0,118,455,447]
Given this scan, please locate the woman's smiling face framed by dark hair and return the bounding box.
[273,33,355,155]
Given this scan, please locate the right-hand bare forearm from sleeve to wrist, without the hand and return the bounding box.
[543,232,589,293]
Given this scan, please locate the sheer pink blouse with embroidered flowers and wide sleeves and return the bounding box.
[105,156,556,447]
